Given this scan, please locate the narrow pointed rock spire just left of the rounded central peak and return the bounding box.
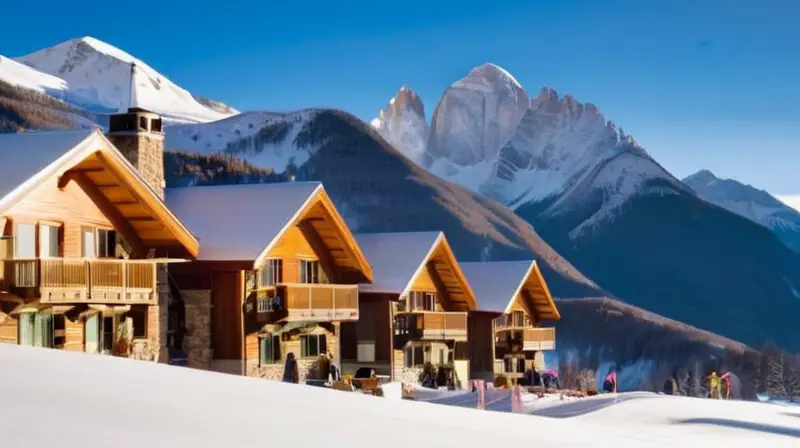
[370,86,430,164]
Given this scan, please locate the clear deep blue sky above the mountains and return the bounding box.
[0,0,800,195]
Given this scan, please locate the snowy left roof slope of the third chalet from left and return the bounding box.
[354,232,442,294]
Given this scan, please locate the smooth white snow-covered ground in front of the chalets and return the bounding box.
[0,344,800,448]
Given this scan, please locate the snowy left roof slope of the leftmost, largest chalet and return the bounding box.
[0,129,96,206]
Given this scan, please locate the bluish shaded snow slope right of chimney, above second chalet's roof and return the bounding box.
[165,109,317,173]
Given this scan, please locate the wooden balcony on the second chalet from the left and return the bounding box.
[256,283,358,322]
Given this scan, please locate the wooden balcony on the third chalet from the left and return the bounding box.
[394,311,467,345]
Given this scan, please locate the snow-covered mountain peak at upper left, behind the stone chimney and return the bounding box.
[17,37,236,123]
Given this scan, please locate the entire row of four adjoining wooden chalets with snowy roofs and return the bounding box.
[0,101,560,387]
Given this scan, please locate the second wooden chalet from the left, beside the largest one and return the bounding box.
[166,182,372,379]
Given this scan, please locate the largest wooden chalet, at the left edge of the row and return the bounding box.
[0,126,199,362]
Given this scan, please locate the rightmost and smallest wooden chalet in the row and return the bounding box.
[461,261,561,380]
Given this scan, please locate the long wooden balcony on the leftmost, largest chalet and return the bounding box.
[4,258,157,305]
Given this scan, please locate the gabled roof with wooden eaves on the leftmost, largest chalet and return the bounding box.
[0,128,199,256]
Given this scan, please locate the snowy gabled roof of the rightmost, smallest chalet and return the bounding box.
[461,260,561,320]
